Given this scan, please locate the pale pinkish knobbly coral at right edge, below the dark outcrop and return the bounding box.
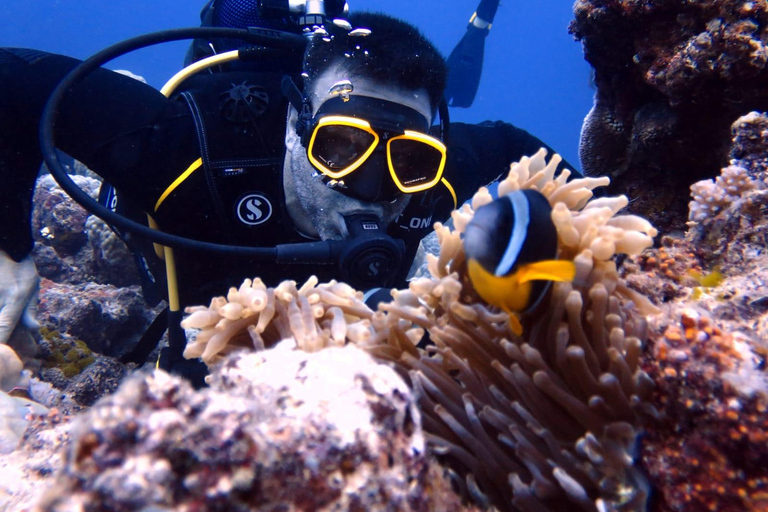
[686,112,768,344]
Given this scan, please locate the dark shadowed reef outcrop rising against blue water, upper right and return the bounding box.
[570,0,768,233]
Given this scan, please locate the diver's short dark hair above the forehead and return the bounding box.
[304,12,448,115]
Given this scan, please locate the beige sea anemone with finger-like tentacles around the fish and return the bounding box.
[183,150,656,511]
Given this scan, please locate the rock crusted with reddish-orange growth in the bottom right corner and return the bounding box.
[642,309,768,512]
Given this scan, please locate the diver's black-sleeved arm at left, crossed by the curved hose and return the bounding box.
[0,49,191,261]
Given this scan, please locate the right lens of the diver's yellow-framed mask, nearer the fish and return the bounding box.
[389,139,443,191]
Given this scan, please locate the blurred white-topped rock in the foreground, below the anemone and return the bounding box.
[35,340,468,511]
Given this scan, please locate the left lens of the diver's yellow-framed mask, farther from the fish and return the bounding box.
[310,124,375,173]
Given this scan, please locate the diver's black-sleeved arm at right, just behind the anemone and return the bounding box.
[446,121,580,204]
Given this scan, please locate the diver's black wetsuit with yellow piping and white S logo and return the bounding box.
[0,49,572,305]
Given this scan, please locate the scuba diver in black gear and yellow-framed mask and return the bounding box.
[0,2,574,384]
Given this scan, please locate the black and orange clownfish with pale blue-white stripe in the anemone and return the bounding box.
[464,190,576,336]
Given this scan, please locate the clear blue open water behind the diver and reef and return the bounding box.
[0,0,592,166]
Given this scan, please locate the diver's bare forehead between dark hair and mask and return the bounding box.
[309,67,432,125]
